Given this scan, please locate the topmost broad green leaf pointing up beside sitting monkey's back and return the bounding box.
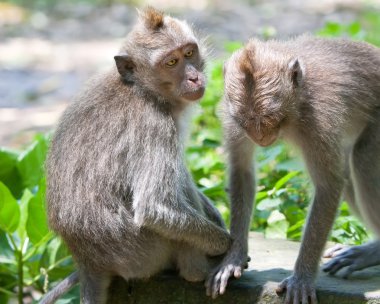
[17,136,48,187]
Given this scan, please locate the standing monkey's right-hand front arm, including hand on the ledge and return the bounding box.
[277,140,344,304]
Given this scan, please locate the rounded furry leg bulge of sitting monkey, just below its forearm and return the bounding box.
[176,244,211,282]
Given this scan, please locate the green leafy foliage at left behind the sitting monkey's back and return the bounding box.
[0,135,73,303]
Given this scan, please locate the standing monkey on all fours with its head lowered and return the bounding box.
[206,35,380,304]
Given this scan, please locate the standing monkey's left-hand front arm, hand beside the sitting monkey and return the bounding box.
[206,128,255,298]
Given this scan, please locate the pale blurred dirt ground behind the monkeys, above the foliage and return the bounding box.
[0,0,380,148]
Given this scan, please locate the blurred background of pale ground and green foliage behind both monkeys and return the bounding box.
[0,0,380,304]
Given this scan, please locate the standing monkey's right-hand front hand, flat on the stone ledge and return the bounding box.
[276,274,318,304]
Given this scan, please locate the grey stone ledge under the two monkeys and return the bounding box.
[108,233,380,304]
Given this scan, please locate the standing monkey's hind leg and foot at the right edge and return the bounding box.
[323,113,380,278]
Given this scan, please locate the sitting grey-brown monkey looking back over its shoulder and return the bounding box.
[42,7,232,304]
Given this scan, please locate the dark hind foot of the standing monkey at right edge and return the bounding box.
[322,240,380,278]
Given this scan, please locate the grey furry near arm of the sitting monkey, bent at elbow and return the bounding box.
[132,145,231,256]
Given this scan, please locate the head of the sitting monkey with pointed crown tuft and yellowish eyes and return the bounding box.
[114,7,206,102]
